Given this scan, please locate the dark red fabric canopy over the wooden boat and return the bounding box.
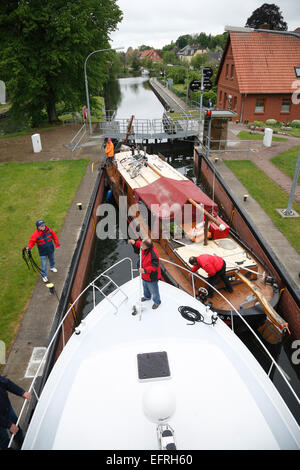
[134,177,218,218]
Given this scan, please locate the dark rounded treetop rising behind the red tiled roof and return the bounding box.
[245,3,288,31]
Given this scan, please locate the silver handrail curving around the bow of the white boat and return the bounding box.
[8,257,300,448]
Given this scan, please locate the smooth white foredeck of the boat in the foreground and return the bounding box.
[23,278,300,450]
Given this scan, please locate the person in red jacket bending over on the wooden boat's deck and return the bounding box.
[189,255,233,297]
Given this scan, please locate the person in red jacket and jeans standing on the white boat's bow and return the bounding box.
[129,238,161,309]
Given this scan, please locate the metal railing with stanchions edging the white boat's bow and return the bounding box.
[8,257,300,447]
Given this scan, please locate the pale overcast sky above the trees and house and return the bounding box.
[111,0,300,52]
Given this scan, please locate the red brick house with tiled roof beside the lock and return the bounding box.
[216,28,300,123]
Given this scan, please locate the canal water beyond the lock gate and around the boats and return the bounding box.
[83,77,300,424]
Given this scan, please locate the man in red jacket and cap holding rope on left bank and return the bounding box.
[26,220,60,282]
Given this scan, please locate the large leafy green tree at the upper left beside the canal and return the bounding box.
[0,0,122,126]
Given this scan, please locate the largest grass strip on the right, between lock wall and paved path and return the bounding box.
[225,160,300,253]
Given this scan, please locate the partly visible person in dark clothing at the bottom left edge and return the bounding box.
[0,375,30,450]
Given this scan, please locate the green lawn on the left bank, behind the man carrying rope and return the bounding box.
[0,160,88,349]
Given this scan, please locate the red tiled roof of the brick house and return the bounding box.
[220,31,300,93]
